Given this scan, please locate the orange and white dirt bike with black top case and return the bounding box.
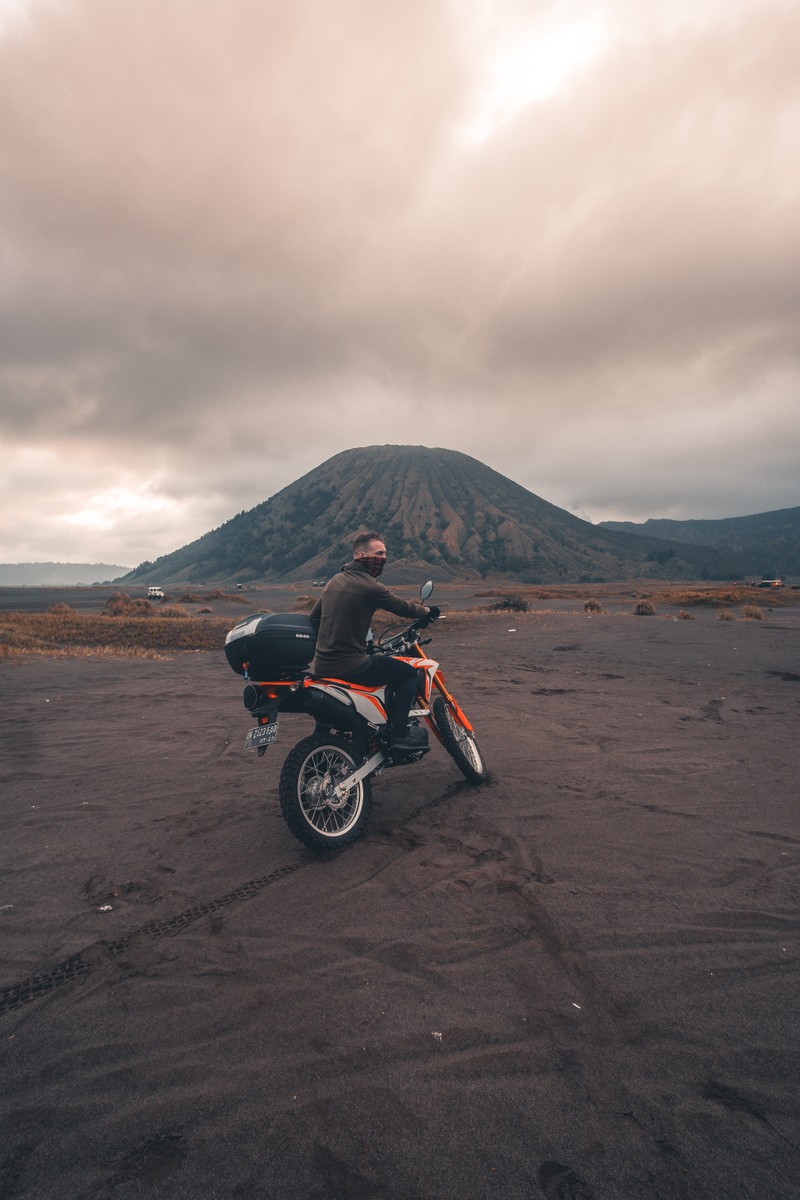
[225,582,487,851]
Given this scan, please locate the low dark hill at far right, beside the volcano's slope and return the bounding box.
[599,508,800,578]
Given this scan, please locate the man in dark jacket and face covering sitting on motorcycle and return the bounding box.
[308,530,439,752]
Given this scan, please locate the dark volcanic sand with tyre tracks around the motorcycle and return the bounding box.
[0,611,800,1200]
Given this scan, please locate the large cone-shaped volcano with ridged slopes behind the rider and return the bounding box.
[125,445,741,584]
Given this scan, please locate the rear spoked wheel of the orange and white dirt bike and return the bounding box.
[279,734,372,850]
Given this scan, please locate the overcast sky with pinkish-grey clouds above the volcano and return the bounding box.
[0,0,800,565]
